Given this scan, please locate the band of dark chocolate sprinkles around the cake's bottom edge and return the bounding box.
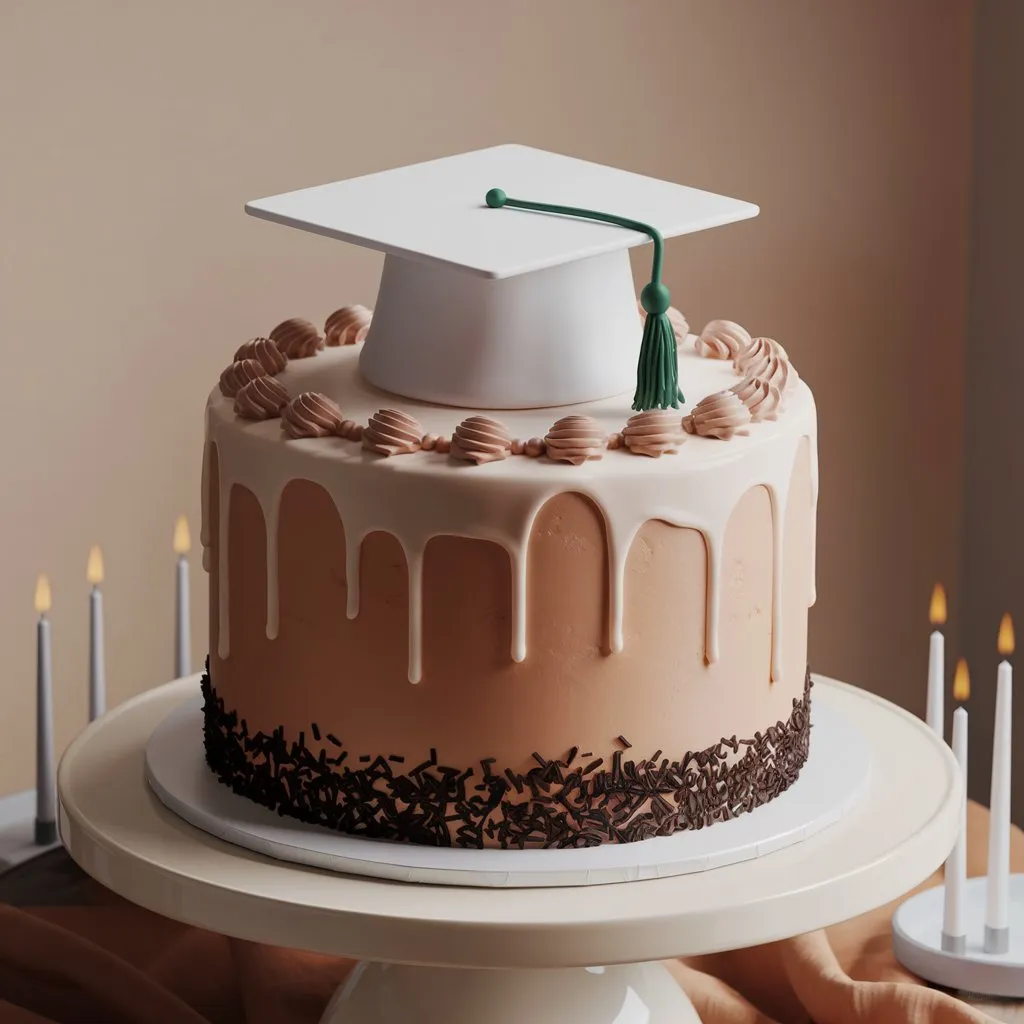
[202,668,811,849]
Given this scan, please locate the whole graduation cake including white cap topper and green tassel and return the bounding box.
[203,145,817,848]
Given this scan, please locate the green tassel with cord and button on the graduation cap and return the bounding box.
[484,188,684,413]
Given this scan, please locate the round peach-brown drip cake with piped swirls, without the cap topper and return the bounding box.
[203,310,817,848]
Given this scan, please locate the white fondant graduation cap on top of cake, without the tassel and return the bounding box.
[246,145,758,409]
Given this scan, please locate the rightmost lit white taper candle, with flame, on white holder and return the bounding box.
[985,615,1014,953]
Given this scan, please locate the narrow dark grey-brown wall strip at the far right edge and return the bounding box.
[964,0,1024,821]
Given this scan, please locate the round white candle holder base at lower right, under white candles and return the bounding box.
[893,874,1024,998]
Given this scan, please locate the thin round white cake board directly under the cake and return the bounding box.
[145,684,871,887]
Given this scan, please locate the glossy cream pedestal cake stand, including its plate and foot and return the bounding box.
[57,679,962,1024]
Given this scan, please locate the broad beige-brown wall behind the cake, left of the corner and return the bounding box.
[0,0,971,794]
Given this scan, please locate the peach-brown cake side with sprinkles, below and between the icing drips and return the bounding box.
[206,437,816,846]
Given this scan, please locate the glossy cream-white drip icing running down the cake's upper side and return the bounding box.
[204,349,818,682]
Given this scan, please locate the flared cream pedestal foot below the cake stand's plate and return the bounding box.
[321,963,700,1024]
